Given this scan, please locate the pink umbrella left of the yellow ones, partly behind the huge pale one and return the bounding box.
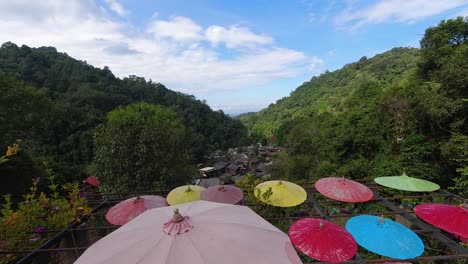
[106,195,167,225]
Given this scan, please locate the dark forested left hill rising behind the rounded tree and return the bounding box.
[0,42,247,182]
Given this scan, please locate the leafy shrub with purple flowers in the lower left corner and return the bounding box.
[0,164,91,263]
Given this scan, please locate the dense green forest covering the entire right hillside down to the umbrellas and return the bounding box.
[239,17,468,196]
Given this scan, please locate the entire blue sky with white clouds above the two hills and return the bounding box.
[0,0,468,115]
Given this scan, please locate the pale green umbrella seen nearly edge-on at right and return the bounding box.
[374,172,440,192]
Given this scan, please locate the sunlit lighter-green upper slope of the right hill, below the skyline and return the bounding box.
[238,48,419,140]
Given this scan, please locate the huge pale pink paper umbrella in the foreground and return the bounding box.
[75,201,302,264]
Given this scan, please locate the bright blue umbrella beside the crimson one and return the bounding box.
[346,215,424,259]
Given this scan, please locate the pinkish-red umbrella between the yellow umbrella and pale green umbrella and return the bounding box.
[315,177,374,203]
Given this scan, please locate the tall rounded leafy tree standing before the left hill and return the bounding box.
[95,103,191,192]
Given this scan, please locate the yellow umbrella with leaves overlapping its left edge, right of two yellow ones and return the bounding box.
[255,181,307,207]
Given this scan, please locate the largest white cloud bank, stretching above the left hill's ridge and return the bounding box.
[0,0,314,104]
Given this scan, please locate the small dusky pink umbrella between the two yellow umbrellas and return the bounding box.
[201,185,244,204]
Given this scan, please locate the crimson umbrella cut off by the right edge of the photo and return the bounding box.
[414,203,468,237]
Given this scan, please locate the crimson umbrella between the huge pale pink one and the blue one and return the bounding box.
[288,218,357,263]
